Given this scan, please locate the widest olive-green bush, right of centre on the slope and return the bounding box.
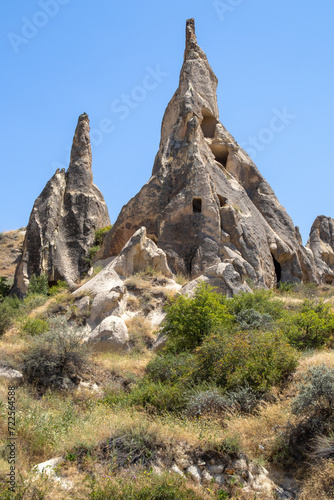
[194,331,298,392]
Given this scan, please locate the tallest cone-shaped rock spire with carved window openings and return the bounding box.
[97,19,317,287]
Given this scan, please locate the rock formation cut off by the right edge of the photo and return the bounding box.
[306,215,334,284]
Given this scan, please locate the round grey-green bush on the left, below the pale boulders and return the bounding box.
[23,317,89,388]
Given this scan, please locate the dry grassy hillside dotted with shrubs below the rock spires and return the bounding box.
[0,273,334,500]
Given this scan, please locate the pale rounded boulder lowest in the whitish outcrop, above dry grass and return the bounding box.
[86,316,130,352]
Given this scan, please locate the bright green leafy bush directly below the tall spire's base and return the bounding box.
[162,283,235,352]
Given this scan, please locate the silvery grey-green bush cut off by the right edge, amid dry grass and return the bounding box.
[292,365,334,417]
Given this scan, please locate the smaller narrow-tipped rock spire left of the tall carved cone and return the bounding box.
[14,113,110,295]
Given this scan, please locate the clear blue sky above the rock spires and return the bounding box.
[0,0,334,243]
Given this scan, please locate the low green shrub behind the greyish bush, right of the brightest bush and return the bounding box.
[226,290,284,320]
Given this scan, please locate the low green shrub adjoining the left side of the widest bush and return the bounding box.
[146,352,195,384]
